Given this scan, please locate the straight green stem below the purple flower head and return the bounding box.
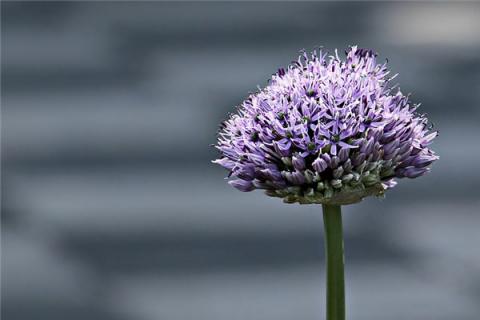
[323,205,345,320]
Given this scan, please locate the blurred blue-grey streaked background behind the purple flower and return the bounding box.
[1,2,480,320]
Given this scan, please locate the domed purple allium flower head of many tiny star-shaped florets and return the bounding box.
[213,46,438,205]
